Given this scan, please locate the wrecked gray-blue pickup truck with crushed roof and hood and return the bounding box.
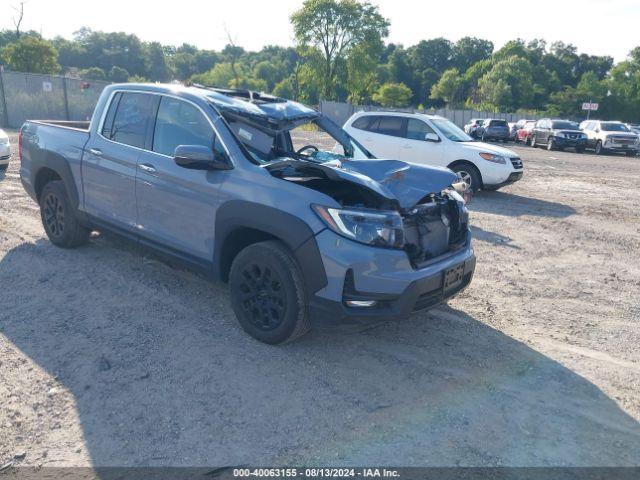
[19,84,475,344]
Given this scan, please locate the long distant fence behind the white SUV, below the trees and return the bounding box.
[320,100,542,127]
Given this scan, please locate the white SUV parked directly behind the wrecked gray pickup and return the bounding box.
[344,112,524,191]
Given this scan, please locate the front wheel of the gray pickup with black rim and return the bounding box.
[229,240,311,345]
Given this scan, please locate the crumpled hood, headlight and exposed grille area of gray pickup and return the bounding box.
[265,160,469,268]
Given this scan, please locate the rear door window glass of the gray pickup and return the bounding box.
[107,93,157,148]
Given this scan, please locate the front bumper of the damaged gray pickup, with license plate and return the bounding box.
[309,230,476,326]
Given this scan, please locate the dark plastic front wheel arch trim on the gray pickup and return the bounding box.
[213,200,327,293]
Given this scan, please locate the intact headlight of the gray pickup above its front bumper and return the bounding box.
[311,205,404,249]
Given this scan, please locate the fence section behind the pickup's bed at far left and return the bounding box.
[0,72,109,128]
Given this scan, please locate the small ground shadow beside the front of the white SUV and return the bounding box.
[469,192,576,218]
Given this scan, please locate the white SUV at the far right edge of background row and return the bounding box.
[580,120,640,157]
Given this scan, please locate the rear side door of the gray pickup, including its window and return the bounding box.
[82,92,158,232]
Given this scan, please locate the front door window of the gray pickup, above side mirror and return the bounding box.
[153,97,214,157]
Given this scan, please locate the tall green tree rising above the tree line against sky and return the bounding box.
[291,0,389,99]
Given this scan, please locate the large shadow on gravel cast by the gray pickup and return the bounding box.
[0,238,640,466]
